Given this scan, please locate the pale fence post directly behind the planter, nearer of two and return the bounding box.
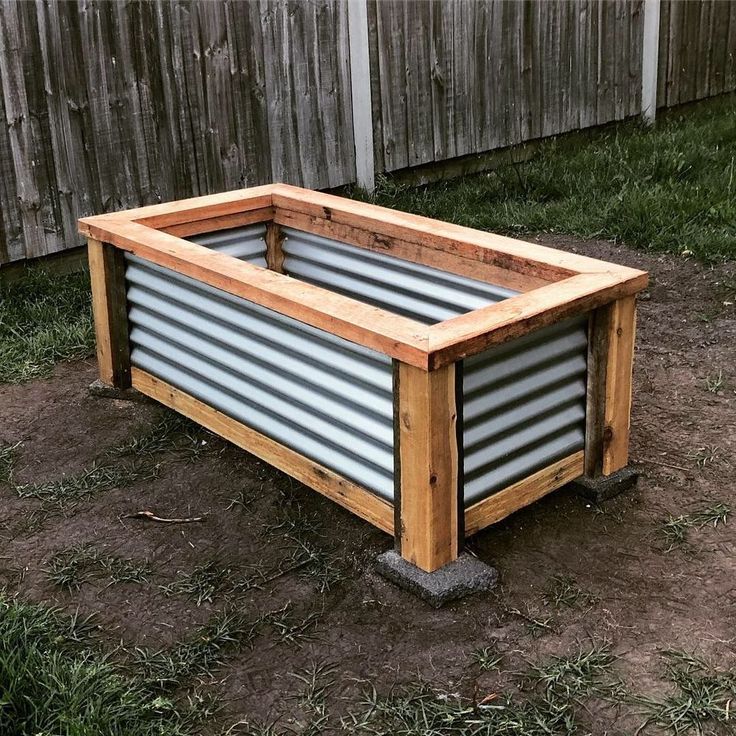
[347,0,375,192]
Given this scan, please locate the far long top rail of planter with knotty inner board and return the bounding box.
[271,184,641,282]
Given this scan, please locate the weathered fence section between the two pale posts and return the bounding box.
[369,0,643,171]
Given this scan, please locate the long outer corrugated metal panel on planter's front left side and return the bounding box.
[126,254,394,500]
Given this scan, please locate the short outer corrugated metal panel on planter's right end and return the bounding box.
[463,317,588,506]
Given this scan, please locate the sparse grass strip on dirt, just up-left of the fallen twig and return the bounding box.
[15,464,158,508]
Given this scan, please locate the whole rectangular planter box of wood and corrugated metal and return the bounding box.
[80,184,647,571]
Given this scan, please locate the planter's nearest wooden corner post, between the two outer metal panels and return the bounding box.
[395,364,460,572]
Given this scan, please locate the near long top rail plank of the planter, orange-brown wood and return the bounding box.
[79,218,428,368]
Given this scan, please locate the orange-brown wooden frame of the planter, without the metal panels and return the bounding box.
[80,184,647,571]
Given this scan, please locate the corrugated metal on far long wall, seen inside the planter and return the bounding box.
[283,227,518,324]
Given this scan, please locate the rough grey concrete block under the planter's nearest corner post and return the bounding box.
[376,550,498,608]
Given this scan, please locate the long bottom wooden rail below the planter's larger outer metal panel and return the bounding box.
[132,367,394,534]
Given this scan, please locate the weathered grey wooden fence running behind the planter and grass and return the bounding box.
[0,0,736,264]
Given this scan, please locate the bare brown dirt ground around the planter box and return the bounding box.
[0,236,736,734]
